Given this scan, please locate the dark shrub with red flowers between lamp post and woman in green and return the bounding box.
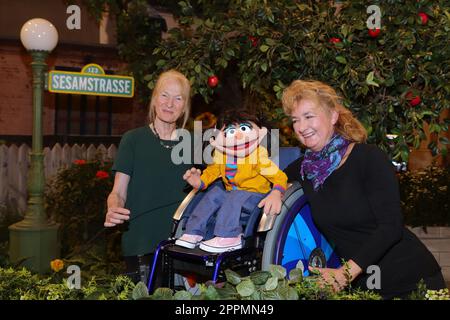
[45,160,121,272]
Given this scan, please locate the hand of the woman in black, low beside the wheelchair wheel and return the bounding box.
[308,260,362,292]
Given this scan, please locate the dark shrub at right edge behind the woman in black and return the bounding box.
[399,166,450,227]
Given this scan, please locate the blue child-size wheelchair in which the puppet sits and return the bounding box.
[147,147,340,292]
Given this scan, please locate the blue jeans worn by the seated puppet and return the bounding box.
[185,186,266,238]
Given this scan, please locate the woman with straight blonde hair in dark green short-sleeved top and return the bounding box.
[104,70,191,281]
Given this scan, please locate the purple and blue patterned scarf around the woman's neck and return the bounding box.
[300,134,350,191]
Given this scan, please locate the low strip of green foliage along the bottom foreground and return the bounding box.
[0,261,450,300]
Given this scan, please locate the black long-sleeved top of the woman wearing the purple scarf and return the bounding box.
[285,144,440,296]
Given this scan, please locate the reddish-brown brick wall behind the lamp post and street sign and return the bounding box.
[0,40,147,135]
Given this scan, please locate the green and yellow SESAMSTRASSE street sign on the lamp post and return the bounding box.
[48,63,134,98]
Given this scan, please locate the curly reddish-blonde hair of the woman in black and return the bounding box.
[281,80,367,143]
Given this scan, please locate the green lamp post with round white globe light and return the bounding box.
[9,18,59,273]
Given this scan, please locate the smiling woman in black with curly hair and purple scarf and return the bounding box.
[282,80,446,299]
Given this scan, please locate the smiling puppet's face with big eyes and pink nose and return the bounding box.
[210,121,267,158]
